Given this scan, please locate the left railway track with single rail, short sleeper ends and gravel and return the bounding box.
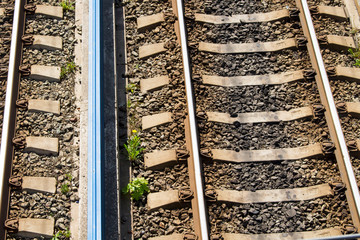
[0,0,79,239]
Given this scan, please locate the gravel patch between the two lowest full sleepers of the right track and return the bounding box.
[209,197,351,234]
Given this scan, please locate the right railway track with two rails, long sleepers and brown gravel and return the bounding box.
[124,0,360,240]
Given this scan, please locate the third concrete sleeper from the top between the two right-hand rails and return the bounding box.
[202,70,304,87]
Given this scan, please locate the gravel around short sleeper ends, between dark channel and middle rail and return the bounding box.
[123,1,193,239]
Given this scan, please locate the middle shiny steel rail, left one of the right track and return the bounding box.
[177,0,209,240]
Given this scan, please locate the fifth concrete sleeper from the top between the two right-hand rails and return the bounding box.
[211,143,323,163]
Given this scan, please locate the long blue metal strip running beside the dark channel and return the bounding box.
[87,0,103,240]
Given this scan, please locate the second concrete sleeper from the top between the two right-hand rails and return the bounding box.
[199,38,297,54]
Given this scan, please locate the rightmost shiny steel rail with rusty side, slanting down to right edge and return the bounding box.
[297,0,360,228]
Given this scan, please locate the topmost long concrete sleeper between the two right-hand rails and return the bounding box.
[195,9,290,24]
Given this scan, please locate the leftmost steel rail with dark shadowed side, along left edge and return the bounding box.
[0,0,26,239]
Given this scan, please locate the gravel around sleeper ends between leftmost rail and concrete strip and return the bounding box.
[8,1,80,239]
